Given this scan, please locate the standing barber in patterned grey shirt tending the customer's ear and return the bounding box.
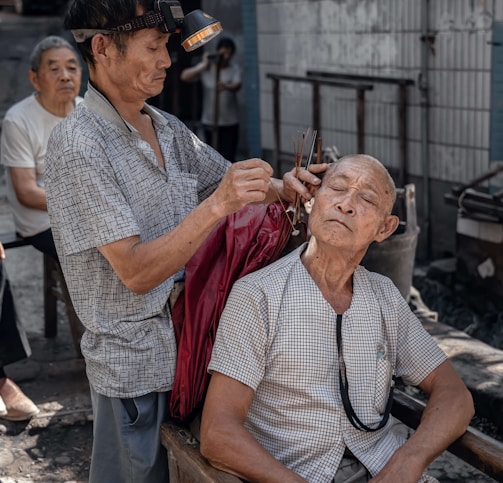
[45,0,324,483]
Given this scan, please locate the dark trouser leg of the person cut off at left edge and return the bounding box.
[0,260,31,369]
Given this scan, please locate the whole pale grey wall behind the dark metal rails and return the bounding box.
[257,0,500,186]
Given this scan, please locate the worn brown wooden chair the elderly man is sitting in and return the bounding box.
[161,390,503,483]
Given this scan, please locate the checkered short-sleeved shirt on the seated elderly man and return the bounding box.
[209,247,446,482]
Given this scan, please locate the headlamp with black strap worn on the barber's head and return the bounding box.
[72,0,222,52]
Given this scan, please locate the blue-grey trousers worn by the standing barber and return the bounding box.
[89,388,169,483]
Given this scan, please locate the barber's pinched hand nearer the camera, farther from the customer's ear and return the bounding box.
[210,158,273,216]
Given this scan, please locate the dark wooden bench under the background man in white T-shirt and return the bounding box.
[0,232,83,357]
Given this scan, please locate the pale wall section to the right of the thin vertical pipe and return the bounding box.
[430,0,493,182]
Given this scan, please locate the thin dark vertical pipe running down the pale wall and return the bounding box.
[419,0,431,258]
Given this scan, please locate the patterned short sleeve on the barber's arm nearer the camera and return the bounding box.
[46,128,139,255]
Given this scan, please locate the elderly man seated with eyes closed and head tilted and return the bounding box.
[201,155,473,483]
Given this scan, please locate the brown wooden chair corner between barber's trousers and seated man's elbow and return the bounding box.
[161,423,242,483]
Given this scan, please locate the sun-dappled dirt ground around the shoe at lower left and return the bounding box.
[0,352,92,483]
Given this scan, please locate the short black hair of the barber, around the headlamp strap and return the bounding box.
[64,0,154,65]
